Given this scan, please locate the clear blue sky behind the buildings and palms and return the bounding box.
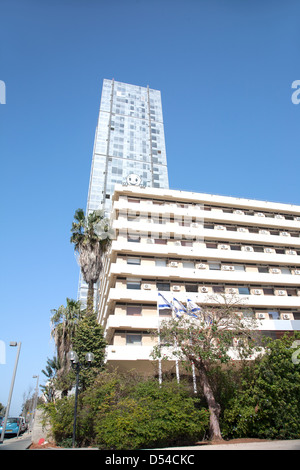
[0,0,300,414]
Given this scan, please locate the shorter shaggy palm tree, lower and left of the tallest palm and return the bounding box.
[51,298,83,376]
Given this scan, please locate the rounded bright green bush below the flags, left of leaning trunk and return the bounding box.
[95,380,209,450]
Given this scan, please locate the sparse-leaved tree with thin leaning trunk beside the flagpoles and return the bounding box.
[153,295,259,440]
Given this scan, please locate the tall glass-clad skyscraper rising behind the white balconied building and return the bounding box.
[79,80,169,303]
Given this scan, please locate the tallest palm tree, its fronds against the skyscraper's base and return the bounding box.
[70,209,111,314]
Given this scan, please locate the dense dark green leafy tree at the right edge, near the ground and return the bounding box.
[222,332,300,439]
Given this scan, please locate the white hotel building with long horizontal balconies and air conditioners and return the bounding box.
[98,184,300,373]
